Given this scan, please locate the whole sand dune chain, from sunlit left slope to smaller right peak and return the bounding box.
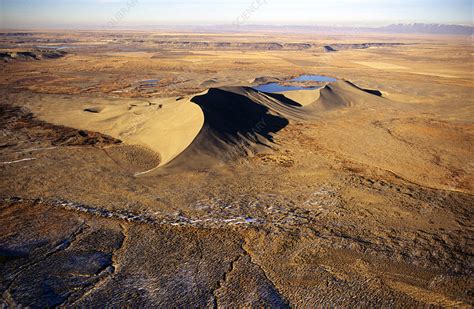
[24,81,385,174]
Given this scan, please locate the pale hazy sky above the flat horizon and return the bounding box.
[0,0,473,28]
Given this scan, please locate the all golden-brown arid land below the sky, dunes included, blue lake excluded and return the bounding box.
[0,31,474,308]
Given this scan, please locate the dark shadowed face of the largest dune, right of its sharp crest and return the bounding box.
[164,87,289,167]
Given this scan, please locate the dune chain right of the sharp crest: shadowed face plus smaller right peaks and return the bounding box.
[164,81,383,168]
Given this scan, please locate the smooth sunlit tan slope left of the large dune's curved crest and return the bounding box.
[25,98,204,165]
